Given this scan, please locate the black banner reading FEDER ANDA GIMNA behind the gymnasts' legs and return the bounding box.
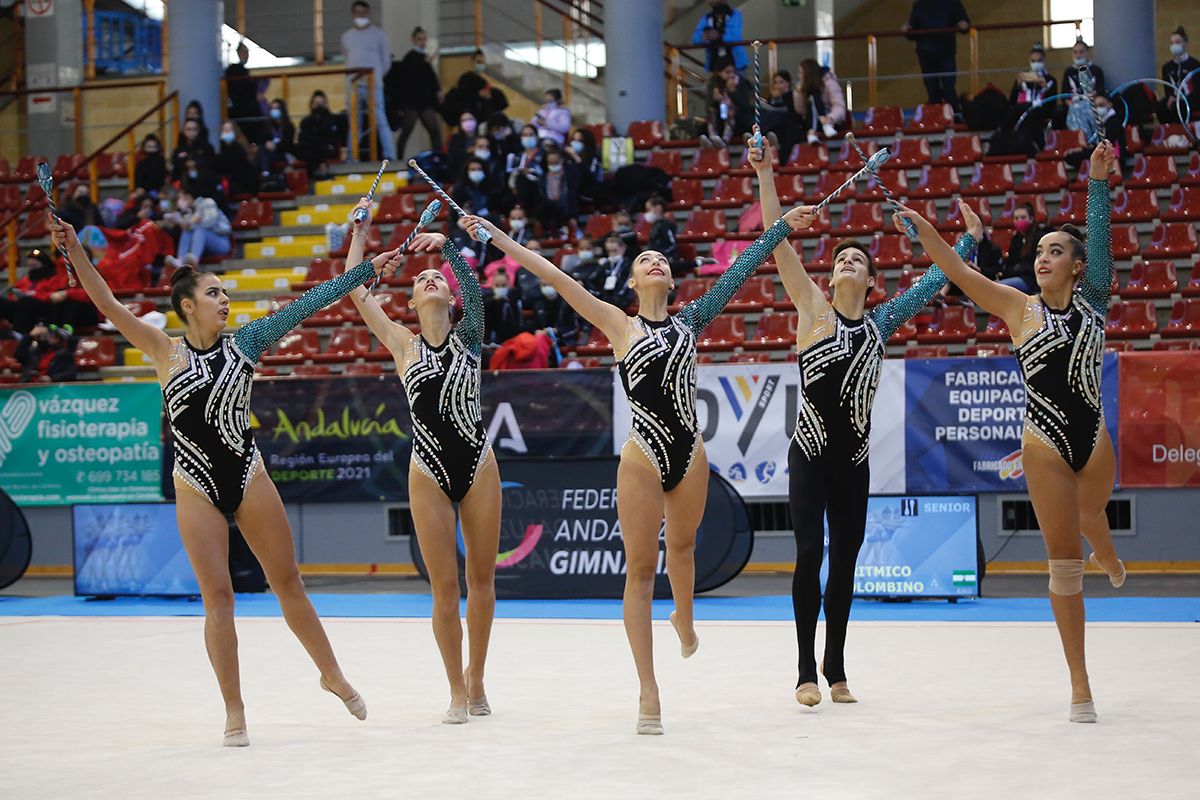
[413,456,754,599]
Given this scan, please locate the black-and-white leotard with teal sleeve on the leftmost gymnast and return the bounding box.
[158,261,374,513]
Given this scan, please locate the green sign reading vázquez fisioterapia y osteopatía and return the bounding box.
[0,384,162,506]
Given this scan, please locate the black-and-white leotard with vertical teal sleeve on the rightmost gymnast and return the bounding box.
[1016,180,1112,473]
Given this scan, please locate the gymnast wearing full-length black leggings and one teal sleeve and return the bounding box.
[749,145,983,706]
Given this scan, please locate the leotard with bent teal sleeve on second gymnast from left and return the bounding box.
[401,241,491,503]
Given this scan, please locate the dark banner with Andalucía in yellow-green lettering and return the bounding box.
[252,369,612,503]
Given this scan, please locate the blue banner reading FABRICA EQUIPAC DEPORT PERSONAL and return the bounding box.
[905,353,1117,493]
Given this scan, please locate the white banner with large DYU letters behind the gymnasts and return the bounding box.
[612,360,905,498]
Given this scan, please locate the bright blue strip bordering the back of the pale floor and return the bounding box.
[0,593,1200,622]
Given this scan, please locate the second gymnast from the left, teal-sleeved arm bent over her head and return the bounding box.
[347,198,500,724]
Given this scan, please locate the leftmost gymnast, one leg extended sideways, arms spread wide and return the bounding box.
[49,216,400,747]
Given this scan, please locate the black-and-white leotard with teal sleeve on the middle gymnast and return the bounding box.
[617,219,792,492]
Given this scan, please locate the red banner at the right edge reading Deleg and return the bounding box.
[1117,351,1200,488]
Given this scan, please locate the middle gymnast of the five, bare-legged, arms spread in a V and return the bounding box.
[463,210,811,735]
